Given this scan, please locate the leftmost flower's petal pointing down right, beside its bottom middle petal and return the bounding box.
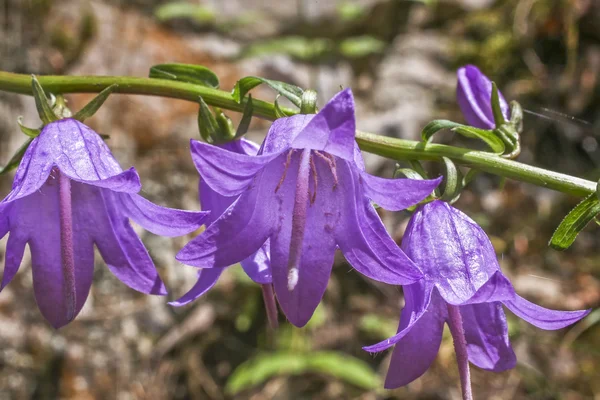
[73,184,167,295]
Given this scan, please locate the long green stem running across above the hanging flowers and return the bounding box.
[0,71,596,196]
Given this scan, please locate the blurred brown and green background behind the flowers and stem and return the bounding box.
[0,0,600,400]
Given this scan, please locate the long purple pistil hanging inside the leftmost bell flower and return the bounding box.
[56,170,76,321]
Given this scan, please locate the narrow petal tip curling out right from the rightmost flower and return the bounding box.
[503,295,592,330]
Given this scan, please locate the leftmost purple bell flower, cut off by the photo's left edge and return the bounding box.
[0,119,207,328]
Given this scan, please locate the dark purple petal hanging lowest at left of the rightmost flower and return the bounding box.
[385,290,447,389]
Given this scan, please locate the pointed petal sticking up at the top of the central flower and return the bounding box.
[292,89,356,161]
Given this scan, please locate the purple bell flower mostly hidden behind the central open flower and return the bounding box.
[169,138,272,306]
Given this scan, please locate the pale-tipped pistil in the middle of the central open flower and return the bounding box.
[288,149,311,292]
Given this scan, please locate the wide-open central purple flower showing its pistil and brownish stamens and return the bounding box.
[177,90,439,326]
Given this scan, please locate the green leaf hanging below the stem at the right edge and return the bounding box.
[549,193,600,251]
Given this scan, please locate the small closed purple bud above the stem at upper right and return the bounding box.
[456,65,510,129]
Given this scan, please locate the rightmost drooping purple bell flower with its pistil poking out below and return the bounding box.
[364,200,590,388]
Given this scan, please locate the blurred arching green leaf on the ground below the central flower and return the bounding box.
[225,351,381,395]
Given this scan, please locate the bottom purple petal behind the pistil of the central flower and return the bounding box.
[271,154,343,327]
